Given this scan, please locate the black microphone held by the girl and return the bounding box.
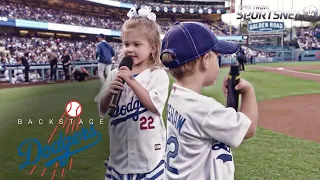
[108,57,133,116]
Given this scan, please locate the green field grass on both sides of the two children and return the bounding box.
[0,68,320,180]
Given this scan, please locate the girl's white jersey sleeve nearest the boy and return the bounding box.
[149,69,169,115]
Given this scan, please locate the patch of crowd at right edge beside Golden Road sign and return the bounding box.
[296,26,320,50]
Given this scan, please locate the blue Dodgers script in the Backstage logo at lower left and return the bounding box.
[18,124,102,170]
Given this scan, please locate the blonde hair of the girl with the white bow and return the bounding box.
[121,17,163,69]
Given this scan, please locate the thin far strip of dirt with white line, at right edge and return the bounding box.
[254,65,320,82]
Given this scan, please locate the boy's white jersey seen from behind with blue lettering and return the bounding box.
[165,84,251,180]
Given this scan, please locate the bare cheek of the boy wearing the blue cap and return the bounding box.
[203,51,220,86]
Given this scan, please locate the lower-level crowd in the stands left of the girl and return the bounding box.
[0,36,121,64]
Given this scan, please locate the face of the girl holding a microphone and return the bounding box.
[122,29,153,67]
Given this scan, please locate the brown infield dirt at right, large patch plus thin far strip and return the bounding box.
[256,66,320,143]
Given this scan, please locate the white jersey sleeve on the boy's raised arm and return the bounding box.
[201,102,251,147]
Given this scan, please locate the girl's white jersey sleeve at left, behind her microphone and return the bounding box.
[94,69,118,118]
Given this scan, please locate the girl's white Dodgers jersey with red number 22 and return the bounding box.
[95,68,169,174]
